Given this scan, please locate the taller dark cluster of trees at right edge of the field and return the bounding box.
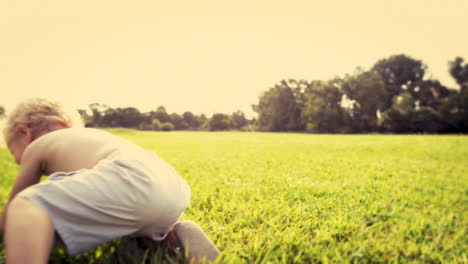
[252,54,468,133]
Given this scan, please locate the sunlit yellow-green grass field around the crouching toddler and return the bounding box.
[0,129,468,263]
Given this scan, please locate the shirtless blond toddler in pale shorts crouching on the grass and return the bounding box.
[0,98,190,263]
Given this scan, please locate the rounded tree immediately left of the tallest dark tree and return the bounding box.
[341,71,387,133]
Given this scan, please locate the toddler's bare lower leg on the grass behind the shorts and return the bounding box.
[171,221,220,263]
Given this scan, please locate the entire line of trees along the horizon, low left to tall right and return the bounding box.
[0,54,468,133]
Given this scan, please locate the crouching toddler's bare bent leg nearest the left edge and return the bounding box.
[5,197,54,264]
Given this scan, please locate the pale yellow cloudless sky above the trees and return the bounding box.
[0,0,468,116]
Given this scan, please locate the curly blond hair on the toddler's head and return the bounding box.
[3,98,74,143]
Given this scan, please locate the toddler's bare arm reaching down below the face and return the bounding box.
[0,144,43,233]
